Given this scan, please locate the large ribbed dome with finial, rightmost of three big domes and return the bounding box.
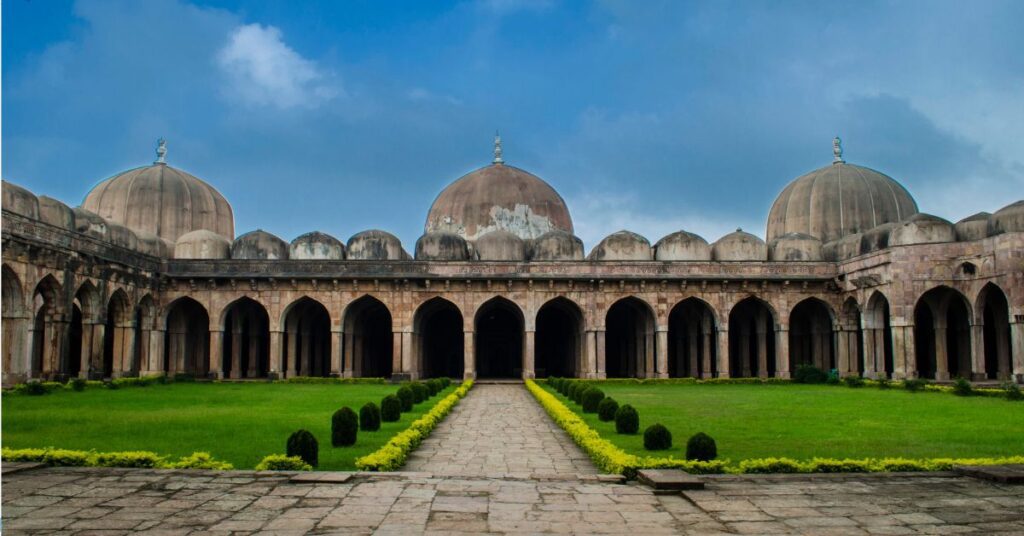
[767,138,918,242]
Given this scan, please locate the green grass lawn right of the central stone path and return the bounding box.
[542,382,1024,461]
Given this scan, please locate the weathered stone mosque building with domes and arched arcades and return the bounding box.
[2,138,1024,385]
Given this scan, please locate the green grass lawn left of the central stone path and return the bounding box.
[3,382,455,470]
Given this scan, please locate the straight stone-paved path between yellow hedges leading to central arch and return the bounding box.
[403,383,597,479]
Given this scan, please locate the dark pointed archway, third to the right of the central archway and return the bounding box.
[669,298,718,378]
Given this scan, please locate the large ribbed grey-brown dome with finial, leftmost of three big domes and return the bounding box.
[82,146,234,242]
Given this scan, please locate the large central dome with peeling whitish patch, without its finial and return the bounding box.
[426,164,572,242]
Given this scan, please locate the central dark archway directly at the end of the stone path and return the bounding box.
[474,297,523,378]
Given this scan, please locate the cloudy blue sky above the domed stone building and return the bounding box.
[2,0,1024,249]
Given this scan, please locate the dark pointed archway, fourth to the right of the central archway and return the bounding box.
[729,297,774,378]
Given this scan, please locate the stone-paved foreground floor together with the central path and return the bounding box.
[2,384,1024,536]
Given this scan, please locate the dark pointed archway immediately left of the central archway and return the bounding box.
[413,297,465,378]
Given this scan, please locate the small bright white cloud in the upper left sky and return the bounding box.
[217,24,341,110]
